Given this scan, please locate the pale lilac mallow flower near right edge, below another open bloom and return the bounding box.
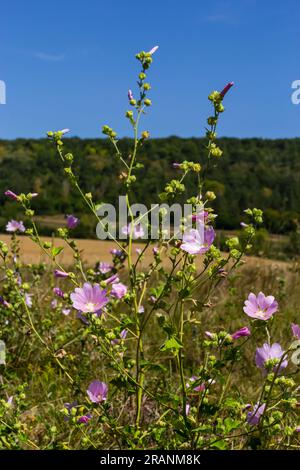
[255,343,288,374]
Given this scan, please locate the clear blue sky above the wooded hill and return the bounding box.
[0,0,300,138]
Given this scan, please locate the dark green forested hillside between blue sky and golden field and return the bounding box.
[0,137,300,236]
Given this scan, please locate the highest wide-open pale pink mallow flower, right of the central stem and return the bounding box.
[180,226,215,255]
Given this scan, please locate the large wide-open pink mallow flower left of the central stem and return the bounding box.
[70,282,108,315]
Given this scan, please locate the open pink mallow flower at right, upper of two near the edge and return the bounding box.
[243,292,278,320]
